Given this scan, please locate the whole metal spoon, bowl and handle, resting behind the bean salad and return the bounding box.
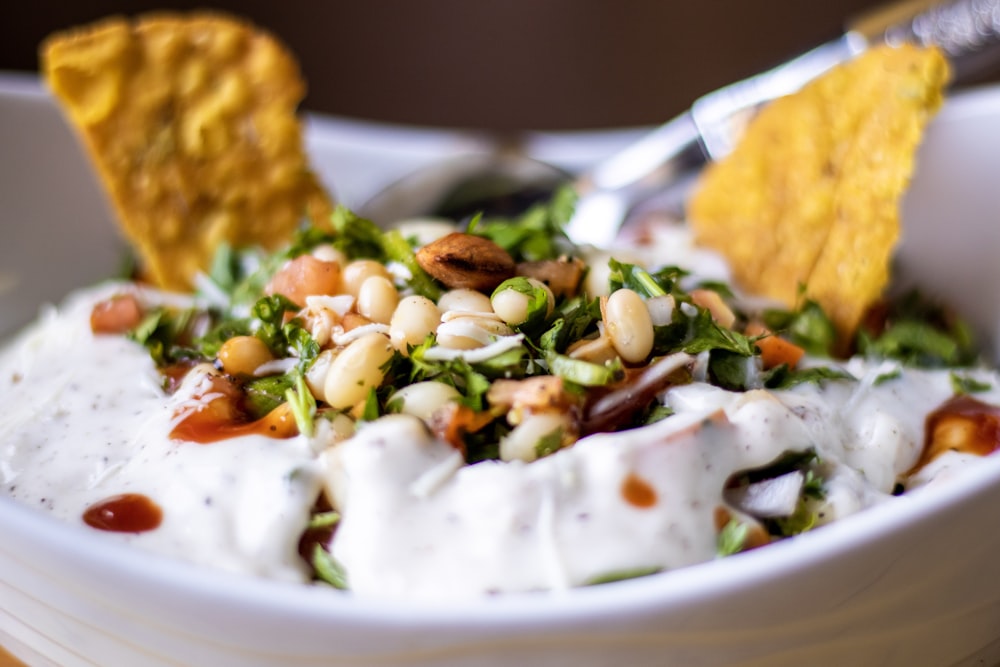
[360,0,1000,246]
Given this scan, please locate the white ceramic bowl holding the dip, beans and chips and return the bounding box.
[0,77,1000,667]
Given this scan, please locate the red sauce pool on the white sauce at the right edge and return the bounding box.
[915,396,1000,470]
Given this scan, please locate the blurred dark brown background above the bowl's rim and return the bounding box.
[0,0,996,130]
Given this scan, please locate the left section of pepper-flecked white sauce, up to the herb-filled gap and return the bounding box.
[0,286,321,581]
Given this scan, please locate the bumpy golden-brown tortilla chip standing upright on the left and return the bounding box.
[41,12,331,290]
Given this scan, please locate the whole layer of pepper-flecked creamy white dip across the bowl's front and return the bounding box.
[0,276,1000,598]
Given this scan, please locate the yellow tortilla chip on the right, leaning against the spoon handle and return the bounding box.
[689,45,948,336]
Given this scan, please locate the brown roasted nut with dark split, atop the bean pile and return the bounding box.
[417,232,515,292]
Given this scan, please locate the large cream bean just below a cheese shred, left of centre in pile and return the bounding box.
[323,333,393,410]
